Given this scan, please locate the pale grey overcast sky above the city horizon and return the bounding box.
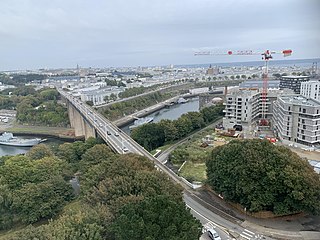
[0,0,320,71]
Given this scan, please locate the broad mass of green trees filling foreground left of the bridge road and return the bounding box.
[0,139,201,240]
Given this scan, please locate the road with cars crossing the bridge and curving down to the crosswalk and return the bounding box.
[58,89,302,240]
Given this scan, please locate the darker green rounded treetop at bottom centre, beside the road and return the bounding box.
[111,195,201,240]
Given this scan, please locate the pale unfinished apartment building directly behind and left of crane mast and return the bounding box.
[223,89,293,128]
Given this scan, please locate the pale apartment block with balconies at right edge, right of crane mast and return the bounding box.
[273,95,320,146]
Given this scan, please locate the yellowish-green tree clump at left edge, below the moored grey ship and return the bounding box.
[0,155,73,226]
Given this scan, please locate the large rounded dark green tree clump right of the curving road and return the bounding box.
[207,139,320,215]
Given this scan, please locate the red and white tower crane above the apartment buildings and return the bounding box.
[194,49,292,126]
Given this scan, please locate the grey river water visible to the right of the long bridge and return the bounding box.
[121,98,199,134]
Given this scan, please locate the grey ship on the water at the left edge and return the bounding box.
[0,132,44,147]
